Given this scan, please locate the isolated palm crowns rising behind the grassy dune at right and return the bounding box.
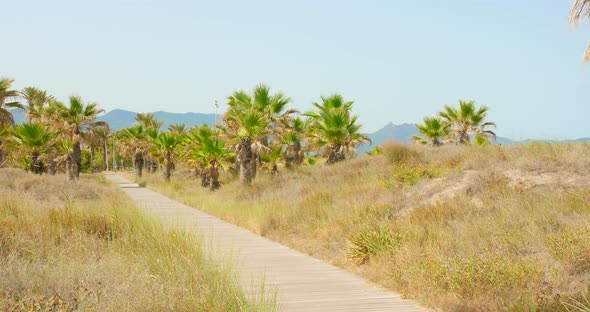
[414,100,496,146]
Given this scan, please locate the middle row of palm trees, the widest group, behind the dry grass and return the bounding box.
[117,84,368,189]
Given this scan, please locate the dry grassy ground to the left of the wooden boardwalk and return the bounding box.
[0,169,273,311]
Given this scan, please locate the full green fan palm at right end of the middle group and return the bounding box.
[305,94,370,164]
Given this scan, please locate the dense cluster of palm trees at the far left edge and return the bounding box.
[0,79,108,180]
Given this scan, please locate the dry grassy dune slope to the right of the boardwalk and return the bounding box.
[144,144,590,311]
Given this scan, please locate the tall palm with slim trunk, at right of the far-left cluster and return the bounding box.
[52,96,103,180]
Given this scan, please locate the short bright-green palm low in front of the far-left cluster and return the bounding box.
[10,122,56,174]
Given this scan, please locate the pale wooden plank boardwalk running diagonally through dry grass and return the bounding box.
[106,174,424,311]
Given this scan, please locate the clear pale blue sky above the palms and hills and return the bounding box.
[0,0,590,139]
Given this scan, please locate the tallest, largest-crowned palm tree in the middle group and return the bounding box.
[223,84,295,185]
